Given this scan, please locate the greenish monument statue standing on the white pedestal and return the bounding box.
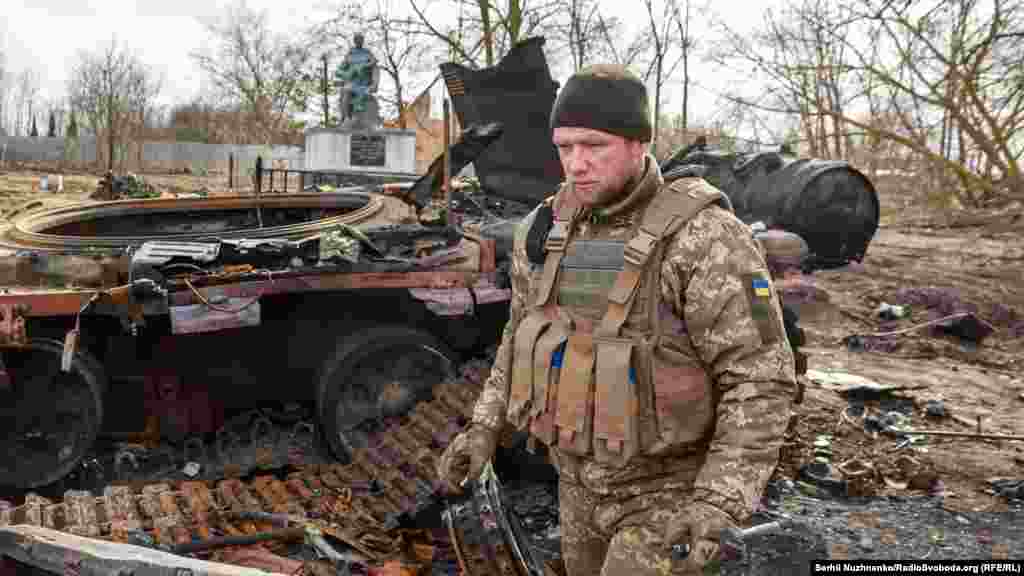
[334,33,380,129]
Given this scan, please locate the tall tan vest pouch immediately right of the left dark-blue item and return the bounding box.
[555,332,594,456]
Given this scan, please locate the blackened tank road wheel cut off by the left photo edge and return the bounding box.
[0,339,106,489]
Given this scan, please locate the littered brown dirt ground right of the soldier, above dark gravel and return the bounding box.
[779,171,1024,511]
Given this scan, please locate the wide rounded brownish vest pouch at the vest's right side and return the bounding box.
[648,345,715,454]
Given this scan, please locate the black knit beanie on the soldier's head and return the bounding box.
[551,65,653,142]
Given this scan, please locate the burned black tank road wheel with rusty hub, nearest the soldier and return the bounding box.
[318,326,455,459]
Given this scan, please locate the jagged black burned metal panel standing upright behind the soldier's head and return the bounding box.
[440,37,563,204]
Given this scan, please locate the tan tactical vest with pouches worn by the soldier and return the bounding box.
[508,178,731,466]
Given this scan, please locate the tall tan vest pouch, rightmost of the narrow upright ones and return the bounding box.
[594,337,640,467]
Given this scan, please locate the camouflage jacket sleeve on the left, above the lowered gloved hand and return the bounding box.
[472,210,537,430]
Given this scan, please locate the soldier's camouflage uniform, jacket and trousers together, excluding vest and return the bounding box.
[473,157,796,576]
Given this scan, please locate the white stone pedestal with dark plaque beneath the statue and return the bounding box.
[305,128,416,174]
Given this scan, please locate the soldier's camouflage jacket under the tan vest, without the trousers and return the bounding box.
[473,158,797,522]
